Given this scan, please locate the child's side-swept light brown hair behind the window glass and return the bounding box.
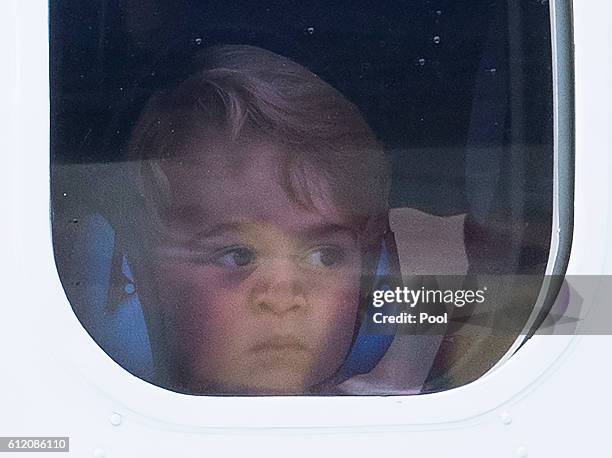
[128,45,389,233]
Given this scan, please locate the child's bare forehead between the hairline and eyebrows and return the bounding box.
[154,144,364,231]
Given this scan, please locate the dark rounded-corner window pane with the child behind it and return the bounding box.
[50,0,568,395]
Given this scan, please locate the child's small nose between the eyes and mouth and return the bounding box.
[252,257,306,315]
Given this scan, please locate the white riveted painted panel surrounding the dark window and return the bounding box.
[0,0,612,458]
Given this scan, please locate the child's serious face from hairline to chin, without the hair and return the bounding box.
[141,136,362,394]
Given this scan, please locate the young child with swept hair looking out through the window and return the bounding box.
[118,45,388,394]
